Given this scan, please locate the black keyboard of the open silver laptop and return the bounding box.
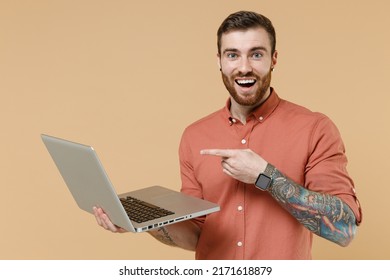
[120,196,175,223]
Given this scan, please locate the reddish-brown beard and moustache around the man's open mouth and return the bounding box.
[222,70,272,106]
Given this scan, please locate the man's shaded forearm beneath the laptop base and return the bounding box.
[148,220,200,251]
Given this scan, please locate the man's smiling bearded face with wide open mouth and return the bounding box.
[219,28,277,107]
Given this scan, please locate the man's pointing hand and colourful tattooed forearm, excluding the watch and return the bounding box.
[201,149,356,246]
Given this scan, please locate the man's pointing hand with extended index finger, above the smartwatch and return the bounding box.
[200,149,267,184]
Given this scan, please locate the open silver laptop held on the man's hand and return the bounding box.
[41,134,220,232]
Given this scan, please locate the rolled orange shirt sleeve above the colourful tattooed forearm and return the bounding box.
[305,115,362,224]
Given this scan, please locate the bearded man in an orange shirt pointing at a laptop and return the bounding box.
[95,11,361,259]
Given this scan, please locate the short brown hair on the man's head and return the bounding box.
[217,11,276,54]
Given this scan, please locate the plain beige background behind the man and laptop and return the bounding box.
[0,0,390,259]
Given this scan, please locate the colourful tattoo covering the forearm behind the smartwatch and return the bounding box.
[269,169,356,246]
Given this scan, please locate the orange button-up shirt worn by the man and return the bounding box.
[179,90,360,259]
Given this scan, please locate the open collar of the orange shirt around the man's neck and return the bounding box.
[224,87,280,123]
